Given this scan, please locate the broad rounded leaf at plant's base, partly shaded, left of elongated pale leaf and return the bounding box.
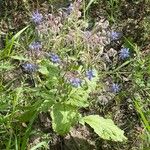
[51,103,79,135]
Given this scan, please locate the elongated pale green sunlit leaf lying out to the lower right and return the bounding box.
[81,115,127,142]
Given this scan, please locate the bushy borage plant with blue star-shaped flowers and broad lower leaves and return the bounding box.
[17,1,126,141]
